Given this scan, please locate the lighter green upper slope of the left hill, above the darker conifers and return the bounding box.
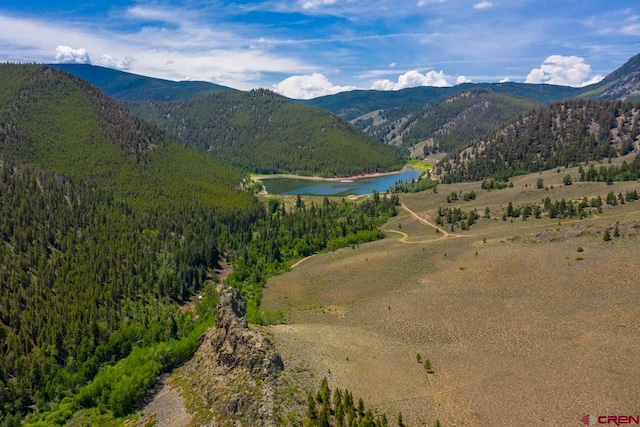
[0,65,247,210]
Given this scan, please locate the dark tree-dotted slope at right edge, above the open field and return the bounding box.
[435,99,640,182]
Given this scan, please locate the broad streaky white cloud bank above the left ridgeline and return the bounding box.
[0,9,316,90]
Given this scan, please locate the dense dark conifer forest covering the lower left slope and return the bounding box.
[0,158,252,422]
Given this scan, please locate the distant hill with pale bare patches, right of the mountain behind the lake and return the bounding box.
[353,88,541,156]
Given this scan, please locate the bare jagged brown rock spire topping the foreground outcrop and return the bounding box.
[211,288,284,380]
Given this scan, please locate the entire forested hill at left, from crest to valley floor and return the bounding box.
[0,64,260,425]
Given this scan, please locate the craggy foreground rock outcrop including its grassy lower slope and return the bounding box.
[178,288,284,427]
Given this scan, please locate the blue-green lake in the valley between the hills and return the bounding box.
[262,168,422,196]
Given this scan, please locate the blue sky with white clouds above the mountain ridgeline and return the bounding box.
[0,0,640,98]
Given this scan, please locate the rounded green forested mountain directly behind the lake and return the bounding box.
[126,89,405,176]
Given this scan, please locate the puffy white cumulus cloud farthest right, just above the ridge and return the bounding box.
[525,55,604,87]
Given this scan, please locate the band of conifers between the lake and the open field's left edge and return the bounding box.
[228,191,399,323]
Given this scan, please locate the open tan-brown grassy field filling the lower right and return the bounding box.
[262,170,640,426]
